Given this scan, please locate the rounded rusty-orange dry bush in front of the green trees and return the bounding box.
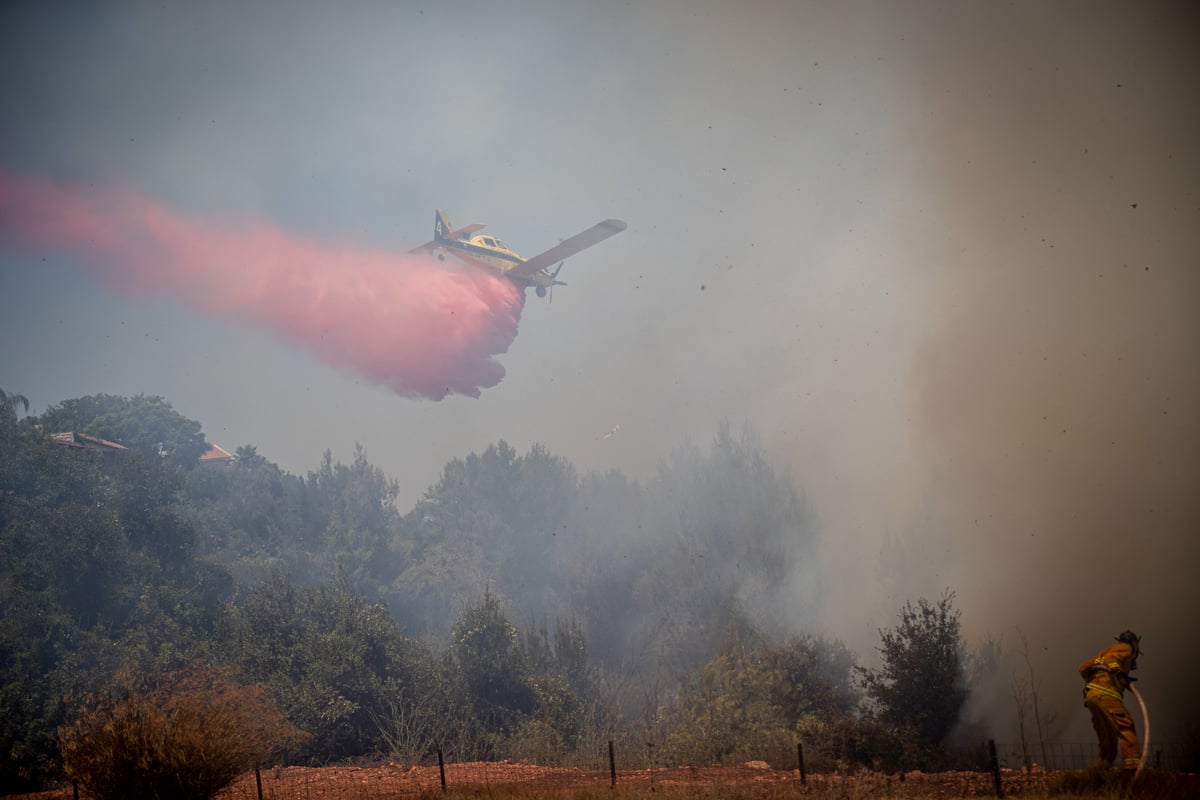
[59,668,305,800]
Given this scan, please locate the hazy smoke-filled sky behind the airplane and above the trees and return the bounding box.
[0,2,1200,738]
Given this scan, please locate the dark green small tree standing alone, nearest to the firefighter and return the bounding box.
[858,591,967,768]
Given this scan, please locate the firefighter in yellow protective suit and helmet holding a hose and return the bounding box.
[1079,631,1141,772]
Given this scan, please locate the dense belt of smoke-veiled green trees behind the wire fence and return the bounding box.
[0,392,988,790]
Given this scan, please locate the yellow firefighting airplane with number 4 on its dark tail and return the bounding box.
[409,209,625,297]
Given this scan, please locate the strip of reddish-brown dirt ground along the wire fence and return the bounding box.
[14,762,1200,800]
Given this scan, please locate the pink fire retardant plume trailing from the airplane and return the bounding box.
[0,169,524,399]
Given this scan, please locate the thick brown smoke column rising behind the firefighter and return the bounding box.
[911,6,1200,738]
